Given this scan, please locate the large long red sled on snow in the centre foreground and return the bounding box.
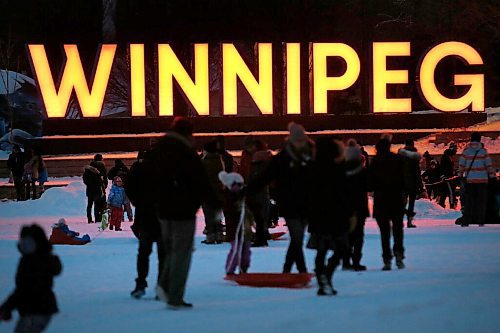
[225,273,313,289]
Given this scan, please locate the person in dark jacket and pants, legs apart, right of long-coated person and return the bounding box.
[368,137,405,270]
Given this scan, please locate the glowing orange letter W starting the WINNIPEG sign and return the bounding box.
[28,44,116,118]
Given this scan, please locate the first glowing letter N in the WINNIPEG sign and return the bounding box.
[158,44,210,116]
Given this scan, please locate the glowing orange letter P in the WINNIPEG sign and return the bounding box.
[313,43,361,113]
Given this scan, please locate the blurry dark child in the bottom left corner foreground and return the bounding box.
[0,224,62,333]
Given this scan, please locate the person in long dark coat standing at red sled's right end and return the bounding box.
[307,137,354,296]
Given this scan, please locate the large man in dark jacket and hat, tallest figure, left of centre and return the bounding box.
[144,117,222,309]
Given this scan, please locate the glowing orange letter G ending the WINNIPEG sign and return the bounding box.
[420,42,484,111]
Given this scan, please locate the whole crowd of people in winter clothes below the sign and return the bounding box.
[0,117,498,326]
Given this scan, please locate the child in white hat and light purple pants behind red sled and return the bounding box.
[219,171,253,275]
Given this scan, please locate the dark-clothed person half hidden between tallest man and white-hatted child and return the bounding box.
[201,141,225,244]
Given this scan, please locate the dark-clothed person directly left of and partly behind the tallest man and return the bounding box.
[124,152,165,298]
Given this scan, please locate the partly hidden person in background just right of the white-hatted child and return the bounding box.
[247,140,272,247]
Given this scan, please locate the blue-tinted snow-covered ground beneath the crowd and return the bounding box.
[0,182,500,333]
